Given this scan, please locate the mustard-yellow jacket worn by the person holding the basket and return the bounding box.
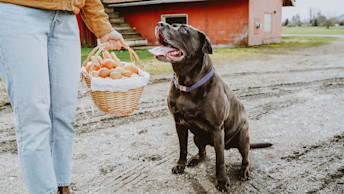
[0,0,114,38]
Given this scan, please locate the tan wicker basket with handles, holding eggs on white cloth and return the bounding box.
[82,43,144,116]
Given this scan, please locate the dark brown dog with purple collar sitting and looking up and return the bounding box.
[150,22,271,191]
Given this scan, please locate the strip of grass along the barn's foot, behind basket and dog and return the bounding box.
[81,37,337,74]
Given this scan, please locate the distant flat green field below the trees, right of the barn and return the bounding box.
[282,26,344,35]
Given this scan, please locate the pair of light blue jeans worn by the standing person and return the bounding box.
[0,2,81,194]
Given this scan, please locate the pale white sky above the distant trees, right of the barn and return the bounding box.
[282,0,344,21]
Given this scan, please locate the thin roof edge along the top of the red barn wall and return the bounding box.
[103,0,206,7]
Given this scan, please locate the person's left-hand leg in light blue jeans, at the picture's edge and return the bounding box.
[0,2,57,193]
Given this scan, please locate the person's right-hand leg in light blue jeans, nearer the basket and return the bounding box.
[48,11,81,186]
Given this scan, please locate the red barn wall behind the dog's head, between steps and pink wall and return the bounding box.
[115,0,249,46]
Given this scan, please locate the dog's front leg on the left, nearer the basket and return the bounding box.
[172,124,188,174]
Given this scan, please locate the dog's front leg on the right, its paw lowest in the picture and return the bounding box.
[213,127,229,192]
